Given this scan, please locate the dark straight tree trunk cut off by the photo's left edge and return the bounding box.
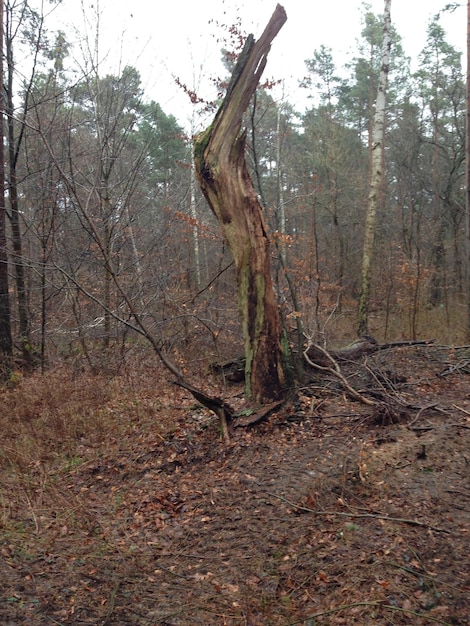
[0,0,13,356]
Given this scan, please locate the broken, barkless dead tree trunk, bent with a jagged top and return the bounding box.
[194,5,287,402]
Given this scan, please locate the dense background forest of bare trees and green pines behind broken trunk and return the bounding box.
[1,2,467,367]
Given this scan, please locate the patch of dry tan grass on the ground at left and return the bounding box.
[0,358,178,534]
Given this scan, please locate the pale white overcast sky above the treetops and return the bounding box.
[48,0,466,123]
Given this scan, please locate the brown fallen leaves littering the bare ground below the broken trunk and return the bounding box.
[0,352,468,626]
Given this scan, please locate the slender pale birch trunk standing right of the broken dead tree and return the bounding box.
[358,0,392,335]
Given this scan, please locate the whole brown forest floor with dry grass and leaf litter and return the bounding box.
[0,346,470,626]
